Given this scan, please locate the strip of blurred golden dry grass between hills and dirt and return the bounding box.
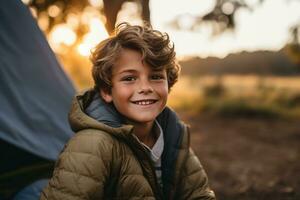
[168,76,300,117]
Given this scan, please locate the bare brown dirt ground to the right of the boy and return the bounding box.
[181,113,300,200]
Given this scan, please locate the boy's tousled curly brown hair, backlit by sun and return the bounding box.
[90,23,180,92]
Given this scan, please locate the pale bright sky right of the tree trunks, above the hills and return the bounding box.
[150,0,300,57]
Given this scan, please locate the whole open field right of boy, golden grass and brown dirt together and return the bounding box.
[169,76,300,200]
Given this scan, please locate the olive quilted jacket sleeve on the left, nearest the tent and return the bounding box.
[41,131,113,200]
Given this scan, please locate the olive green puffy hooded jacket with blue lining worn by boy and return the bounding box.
[41,91,215,200]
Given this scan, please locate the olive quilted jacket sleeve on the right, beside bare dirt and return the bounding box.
[177,149,216,200]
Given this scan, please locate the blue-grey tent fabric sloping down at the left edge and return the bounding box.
[0,0,75,162]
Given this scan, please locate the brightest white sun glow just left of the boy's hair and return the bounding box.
[77,17,108,56]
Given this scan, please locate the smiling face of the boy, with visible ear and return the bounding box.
[101,49,168,123]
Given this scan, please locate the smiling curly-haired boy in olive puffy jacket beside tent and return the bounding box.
[41,23,215,199]
